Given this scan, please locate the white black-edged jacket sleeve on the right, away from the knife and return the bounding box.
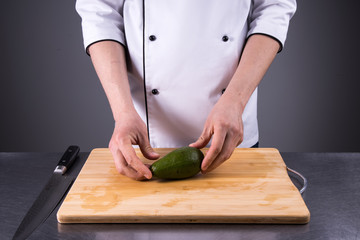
[247,0,296,52]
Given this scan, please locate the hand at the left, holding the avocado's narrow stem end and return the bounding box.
[109,112,159,180]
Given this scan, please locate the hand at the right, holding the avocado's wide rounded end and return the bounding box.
[189,94,243,173]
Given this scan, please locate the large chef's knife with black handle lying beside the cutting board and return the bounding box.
[13,146,80,240]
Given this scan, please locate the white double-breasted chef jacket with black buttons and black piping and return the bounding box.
[76,0,296,148]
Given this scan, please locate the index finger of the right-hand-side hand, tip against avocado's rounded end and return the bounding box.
[201,129,226,172]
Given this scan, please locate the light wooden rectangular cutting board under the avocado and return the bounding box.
[57,148,310,224]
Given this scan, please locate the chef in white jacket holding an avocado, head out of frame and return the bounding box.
[76,0,296,180]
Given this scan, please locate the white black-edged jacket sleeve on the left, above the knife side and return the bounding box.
[75,0,126,54]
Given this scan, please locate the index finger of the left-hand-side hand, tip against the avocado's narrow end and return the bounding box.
[120,142,152,179]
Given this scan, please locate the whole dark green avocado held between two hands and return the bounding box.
[150,147,204,179]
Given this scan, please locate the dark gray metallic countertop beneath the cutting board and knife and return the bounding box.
[0,152,360,240]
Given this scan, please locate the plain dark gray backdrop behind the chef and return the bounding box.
[0,0,360,152]
